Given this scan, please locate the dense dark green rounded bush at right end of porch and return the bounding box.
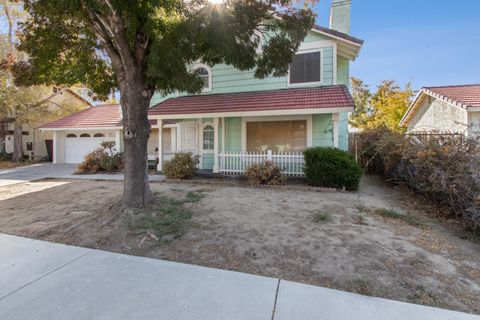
[304,147,363,190]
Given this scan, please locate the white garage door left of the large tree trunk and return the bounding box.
[65,134,108,163]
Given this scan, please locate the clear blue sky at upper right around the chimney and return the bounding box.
[316,0,480,89]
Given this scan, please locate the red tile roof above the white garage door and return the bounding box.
[40,104,122,129]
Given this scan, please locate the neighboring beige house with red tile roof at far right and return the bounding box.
[400,84,480,135]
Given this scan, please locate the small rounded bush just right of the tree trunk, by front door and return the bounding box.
[162,152,200,179]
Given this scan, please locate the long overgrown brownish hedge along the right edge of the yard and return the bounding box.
[359,129,480,232]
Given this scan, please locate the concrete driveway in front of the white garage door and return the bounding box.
[0,163,77,187]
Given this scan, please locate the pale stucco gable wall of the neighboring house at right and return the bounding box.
[407,97,467,133]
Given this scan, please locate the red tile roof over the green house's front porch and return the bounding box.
[149,85,354,115]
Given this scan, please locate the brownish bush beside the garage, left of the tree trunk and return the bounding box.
[77,141,123,174]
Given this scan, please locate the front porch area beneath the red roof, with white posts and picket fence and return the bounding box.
[155,113,343,176]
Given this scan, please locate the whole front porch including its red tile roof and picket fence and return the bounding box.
[149,86,354,175]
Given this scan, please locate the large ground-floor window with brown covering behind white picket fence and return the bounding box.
[247,120,307,152]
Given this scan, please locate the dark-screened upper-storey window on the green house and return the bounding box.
[290,51,321,84]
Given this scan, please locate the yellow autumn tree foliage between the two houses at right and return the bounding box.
[350,78,414,132]
